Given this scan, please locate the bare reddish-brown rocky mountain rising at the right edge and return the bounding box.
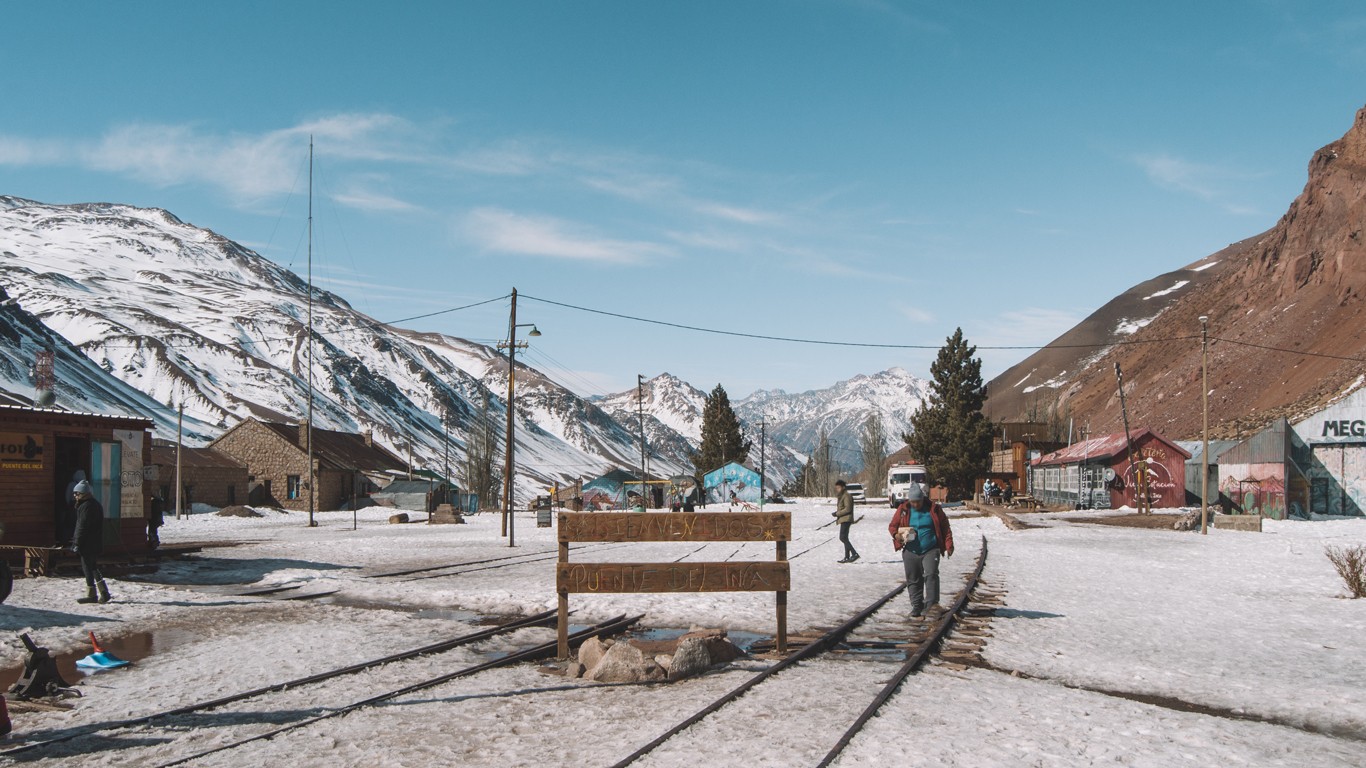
[988,108,1366,440]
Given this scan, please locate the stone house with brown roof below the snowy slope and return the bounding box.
[209,418,408,511]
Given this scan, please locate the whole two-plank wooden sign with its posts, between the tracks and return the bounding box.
[555,512,792,659]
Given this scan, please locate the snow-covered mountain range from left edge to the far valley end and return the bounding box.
[0,195,925,497]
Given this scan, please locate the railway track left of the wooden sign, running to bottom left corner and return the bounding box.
[0,611,639,765]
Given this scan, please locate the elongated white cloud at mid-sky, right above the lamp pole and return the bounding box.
[463,208,668,264]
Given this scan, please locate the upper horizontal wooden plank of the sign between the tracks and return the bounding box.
[559,512,792,541]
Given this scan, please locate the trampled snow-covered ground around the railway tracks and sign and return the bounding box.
[0,500,1366,768]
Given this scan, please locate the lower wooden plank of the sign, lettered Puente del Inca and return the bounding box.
[555,560,792,594]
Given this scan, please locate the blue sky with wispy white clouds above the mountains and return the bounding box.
[0,0,1366,398]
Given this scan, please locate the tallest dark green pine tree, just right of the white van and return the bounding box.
[903,328,992,499]
